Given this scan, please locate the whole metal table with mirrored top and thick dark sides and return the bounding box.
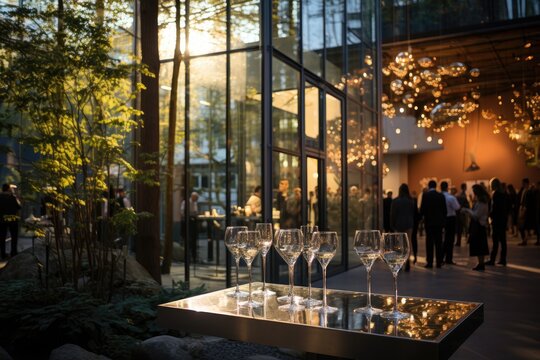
[157,283,484,359]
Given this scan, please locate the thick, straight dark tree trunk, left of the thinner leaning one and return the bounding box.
[136,0,161,284]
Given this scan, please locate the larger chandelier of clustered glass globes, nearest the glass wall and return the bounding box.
[381,51,480,132]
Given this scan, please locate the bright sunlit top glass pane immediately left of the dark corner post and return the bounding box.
[231,0,260,49]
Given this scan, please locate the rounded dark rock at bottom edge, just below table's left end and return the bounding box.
[131,335,192,360]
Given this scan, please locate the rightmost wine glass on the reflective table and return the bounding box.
[381,233,410,320]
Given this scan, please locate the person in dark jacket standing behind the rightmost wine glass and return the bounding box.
[389,184,416,271]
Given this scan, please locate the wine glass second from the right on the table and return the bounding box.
[354,230,382,315]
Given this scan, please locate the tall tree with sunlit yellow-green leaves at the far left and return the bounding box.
[0,0,153,296]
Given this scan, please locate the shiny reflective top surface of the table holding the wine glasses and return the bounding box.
[163,283,480,340]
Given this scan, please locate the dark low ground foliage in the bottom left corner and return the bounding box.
[0,281,204,359]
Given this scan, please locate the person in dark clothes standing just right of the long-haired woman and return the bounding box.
[486,178,508,265]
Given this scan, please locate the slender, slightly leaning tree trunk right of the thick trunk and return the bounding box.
[161,0,182,274]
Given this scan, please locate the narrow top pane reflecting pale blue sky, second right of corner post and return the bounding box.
[302,0,324,76]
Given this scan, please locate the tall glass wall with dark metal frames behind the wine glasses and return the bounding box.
[156,0,378,289]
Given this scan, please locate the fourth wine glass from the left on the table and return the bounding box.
[275,229,304,311]
